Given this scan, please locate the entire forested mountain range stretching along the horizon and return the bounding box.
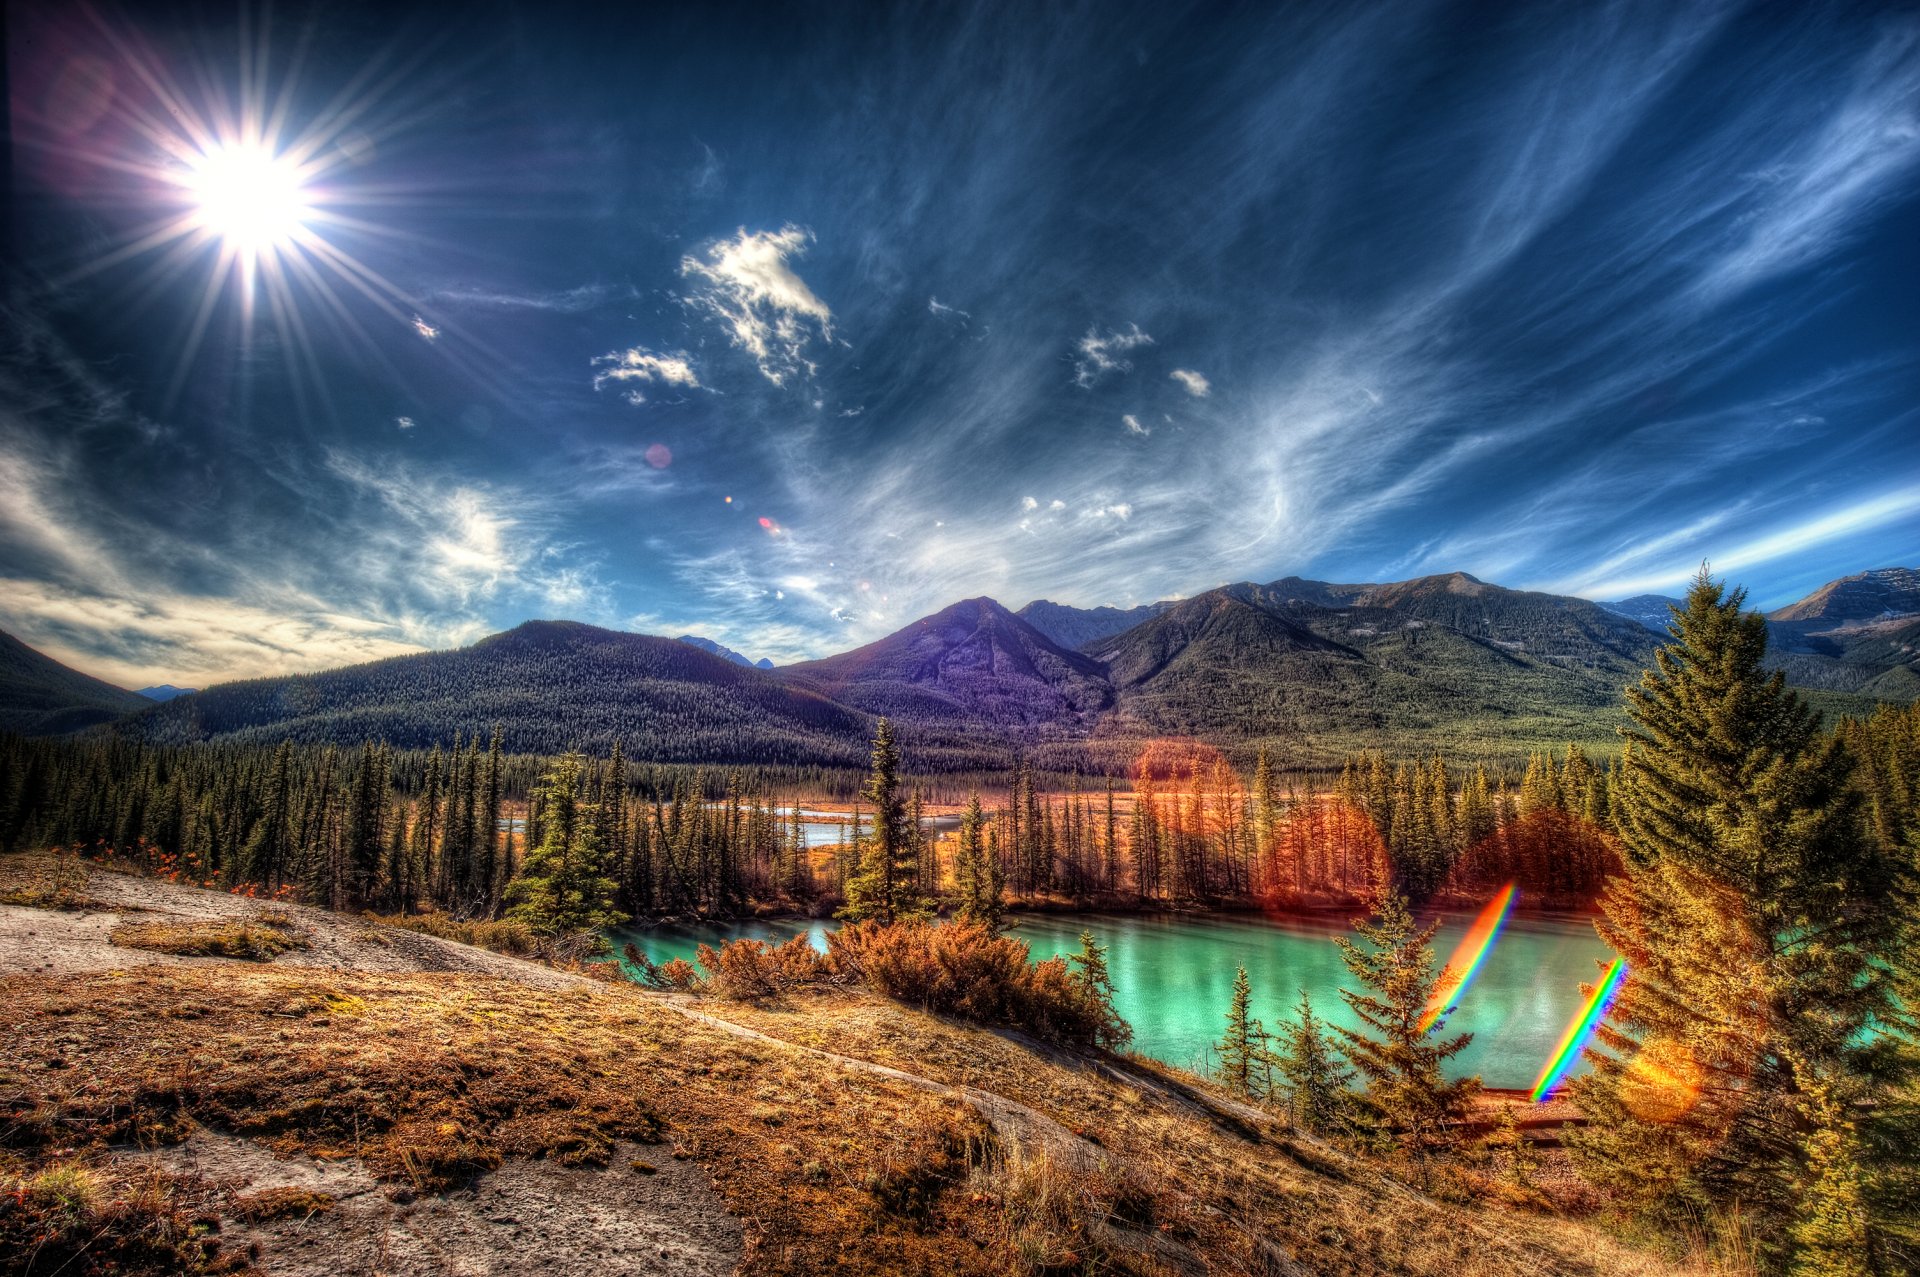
[0,568,1920,770]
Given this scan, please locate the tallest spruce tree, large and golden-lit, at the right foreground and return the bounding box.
[1571,568,1912,1271]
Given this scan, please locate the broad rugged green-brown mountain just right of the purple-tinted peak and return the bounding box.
[1089,574,1657,764]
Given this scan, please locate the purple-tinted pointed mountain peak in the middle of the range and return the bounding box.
[780,599,1114,735]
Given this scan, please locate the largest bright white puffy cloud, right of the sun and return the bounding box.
[680,225,833,386]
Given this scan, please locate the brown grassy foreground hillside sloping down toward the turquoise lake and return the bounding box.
[0,856,1712,1277]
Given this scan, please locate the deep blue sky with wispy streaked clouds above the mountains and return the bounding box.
[0,2,1920,686]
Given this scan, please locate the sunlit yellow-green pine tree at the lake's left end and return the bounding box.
[507,755,626,935]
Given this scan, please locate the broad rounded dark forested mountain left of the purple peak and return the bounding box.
[127,620,872,766]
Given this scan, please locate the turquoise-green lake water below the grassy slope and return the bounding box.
[612,914,1609,1089]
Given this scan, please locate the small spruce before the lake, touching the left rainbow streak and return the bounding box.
[1334,893,1480,1156]
